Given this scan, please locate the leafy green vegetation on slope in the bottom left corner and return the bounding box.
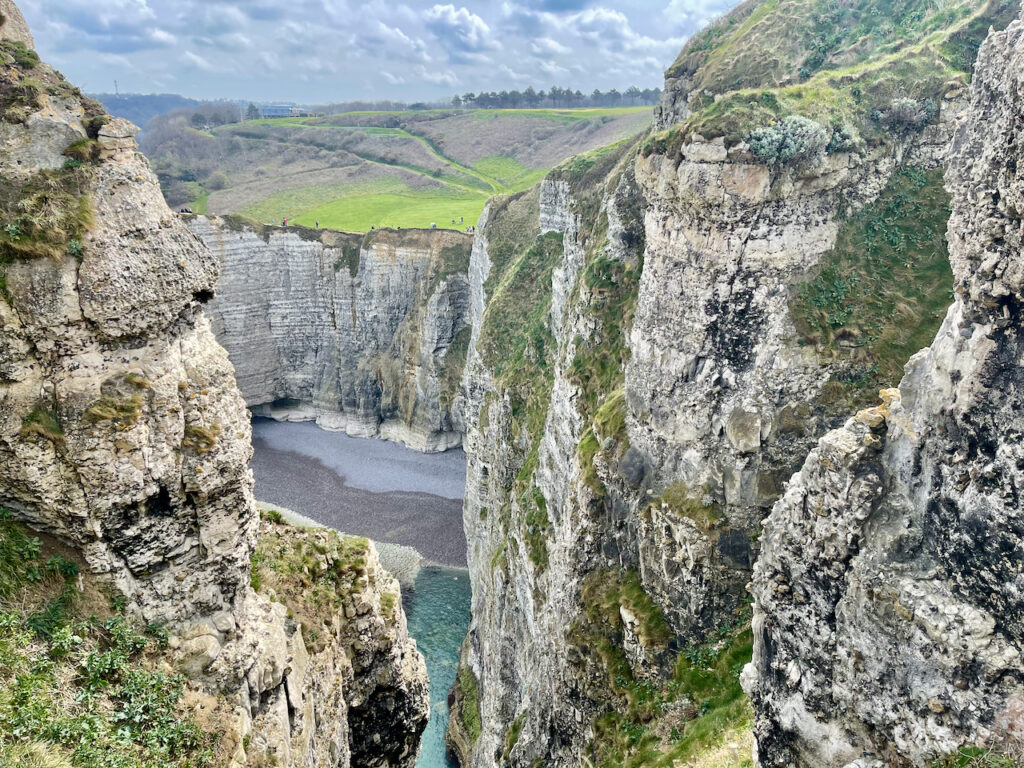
[0,511,216,768]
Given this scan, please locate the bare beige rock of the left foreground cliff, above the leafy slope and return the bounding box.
[0,9,428,768]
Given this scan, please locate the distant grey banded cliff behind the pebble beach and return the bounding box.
[189,217,471,452]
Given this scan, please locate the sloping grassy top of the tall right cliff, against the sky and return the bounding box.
[666,0,1019,143]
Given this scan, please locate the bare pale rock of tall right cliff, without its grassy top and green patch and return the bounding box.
[450,34,963,766]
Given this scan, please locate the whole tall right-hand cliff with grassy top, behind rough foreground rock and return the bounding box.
[450,0,1002,766]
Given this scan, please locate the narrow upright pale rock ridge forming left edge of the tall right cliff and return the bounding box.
[449,165,655,766]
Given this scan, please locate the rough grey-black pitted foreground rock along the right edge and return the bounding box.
[745,13,1024,768]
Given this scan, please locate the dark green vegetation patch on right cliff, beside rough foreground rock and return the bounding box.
[790,168,953,411]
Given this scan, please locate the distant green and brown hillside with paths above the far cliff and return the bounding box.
[142,108,651,231]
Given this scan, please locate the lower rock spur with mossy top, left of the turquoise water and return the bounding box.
[192,522,430,768]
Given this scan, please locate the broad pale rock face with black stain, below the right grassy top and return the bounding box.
[626,108,962,640]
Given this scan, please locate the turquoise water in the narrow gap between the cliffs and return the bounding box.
[403,565,471,768]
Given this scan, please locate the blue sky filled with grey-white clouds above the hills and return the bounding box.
[18,0,734,102]
